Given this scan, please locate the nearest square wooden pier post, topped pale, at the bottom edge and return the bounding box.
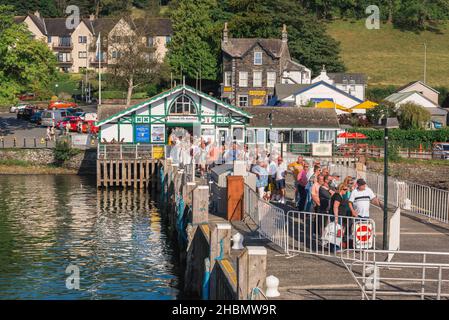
[237,246,267,300]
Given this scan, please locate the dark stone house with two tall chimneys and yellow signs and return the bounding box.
[221,24,312,107]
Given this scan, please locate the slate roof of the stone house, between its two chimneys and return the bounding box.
[221,38,282,58]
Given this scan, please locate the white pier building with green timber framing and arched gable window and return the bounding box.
[97,85,252,145]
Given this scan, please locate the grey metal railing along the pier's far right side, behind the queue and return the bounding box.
[331,165,449,223]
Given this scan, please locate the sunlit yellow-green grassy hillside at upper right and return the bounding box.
[328,21,449,87]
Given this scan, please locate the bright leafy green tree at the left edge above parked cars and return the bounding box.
[0,5,57,105]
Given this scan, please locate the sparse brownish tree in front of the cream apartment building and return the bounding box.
[108,18,161,106]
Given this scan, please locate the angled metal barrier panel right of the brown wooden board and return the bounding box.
[244,184,287,252]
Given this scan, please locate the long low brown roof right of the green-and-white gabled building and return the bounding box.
[242,107,340,128]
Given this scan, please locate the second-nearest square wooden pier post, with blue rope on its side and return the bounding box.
[209,222,231,300]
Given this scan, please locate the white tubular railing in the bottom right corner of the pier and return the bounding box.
[343,250,449,300]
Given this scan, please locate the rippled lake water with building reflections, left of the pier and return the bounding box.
[0,175,179,299]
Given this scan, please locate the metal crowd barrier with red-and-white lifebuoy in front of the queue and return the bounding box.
[287,211,376,260]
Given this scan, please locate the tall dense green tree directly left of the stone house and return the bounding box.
[168,0,220,80]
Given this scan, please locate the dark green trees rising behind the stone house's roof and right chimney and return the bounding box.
[228,0,345,75]
